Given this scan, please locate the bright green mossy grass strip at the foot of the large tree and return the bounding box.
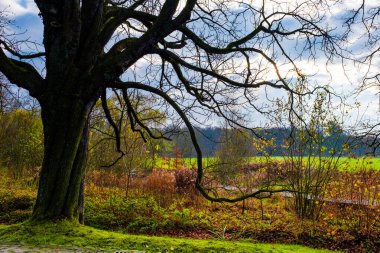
[0,221,338,253]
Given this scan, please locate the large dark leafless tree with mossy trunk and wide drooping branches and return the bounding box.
[0,0,368,220]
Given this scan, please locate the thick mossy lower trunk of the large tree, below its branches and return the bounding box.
[32,97,94,220]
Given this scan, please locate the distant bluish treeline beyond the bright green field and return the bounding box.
[162,127,372,157]
